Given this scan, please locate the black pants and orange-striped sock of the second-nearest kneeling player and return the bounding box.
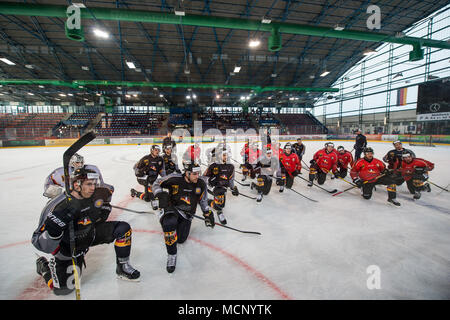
[159,208,191,254]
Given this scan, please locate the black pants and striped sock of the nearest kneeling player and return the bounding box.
[43,221,132,295]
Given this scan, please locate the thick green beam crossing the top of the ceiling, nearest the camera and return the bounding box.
[0,2,450,49]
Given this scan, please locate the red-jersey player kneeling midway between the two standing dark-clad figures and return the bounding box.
[308,142,339,187]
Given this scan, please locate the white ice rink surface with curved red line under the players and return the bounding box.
[0,141,450,300]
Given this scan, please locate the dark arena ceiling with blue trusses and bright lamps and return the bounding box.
[0,0,447,106]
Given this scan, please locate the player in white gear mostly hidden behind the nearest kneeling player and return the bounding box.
[43,153,114,199]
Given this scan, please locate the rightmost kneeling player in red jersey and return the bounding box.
[394,150,434,199]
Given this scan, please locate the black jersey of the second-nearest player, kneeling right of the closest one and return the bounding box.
[152,173,210,219]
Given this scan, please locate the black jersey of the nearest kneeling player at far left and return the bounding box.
[31,187,111,259]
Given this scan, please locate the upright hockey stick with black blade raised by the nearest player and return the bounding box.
[63,131,95,300]
